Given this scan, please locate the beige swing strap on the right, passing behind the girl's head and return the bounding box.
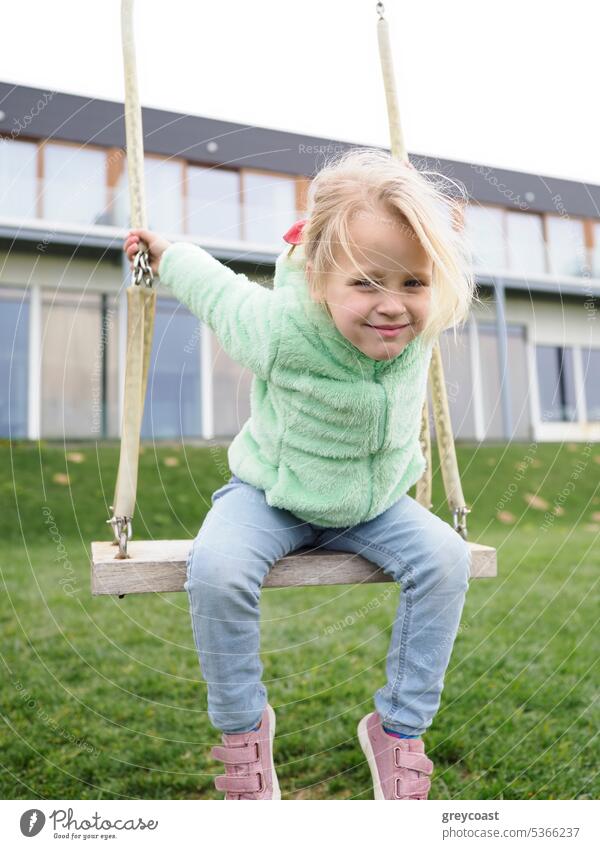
[376,3,471,539]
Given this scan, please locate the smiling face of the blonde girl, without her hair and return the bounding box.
[307,208,433,360]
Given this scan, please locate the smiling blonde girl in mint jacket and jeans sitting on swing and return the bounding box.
[125,148,474,800]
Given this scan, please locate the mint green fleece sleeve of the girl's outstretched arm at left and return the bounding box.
[158,242,281,380]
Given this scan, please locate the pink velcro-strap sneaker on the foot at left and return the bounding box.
[210,704,281,800]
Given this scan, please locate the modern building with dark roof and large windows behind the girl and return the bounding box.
[0,83,600,441]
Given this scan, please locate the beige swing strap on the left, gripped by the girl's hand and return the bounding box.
[108,0,156,558]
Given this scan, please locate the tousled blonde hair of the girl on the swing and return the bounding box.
[298,148,477,341]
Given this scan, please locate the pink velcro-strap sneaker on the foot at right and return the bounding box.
[358,712,433,799]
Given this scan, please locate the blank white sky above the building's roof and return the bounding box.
[0,0,600,184]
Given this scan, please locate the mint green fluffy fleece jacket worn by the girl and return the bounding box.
[158,242,433,528]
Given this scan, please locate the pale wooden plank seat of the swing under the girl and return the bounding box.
[92,539,497,596]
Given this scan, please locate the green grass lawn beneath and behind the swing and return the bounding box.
[0,442,600,800]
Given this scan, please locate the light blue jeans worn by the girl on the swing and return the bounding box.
[184,475,470,735]
